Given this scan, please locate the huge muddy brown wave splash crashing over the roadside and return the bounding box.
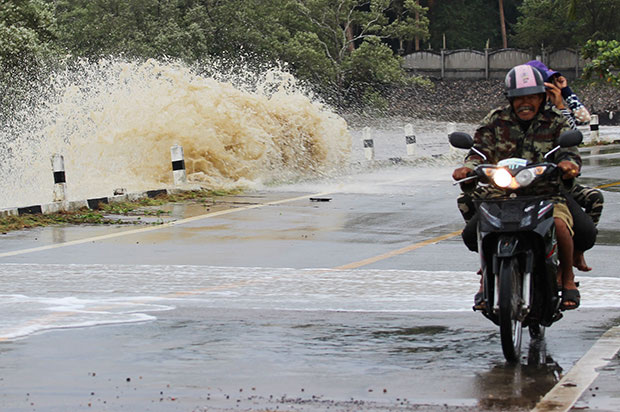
[0,59,351,208]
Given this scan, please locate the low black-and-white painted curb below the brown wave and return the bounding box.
[0,185,202,218]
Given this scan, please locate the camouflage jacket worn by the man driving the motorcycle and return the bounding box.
[464,106,581,200]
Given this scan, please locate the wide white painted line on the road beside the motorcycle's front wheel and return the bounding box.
[532,326,620,412]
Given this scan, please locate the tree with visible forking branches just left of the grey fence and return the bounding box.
[297,0,428,95]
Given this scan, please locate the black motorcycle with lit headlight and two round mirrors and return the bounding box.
[449,130,583,362]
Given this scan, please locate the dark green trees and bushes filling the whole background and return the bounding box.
[0,0,620,109]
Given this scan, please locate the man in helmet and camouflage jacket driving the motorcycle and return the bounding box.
[452,65,581,310]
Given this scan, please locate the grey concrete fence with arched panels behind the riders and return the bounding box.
[403,49,586,80]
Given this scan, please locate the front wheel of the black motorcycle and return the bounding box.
[498,258,523,363]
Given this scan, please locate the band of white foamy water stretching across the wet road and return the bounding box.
[0,264,620,339]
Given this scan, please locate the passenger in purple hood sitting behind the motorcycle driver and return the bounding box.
[526,60,604,272]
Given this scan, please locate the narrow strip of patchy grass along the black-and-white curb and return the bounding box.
[0,190,238,234]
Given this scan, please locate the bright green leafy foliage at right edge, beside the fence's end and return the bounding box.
[582,40,620,87]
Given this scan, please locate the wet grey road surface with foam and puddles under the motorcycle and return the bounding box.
[0,149,620,411]
